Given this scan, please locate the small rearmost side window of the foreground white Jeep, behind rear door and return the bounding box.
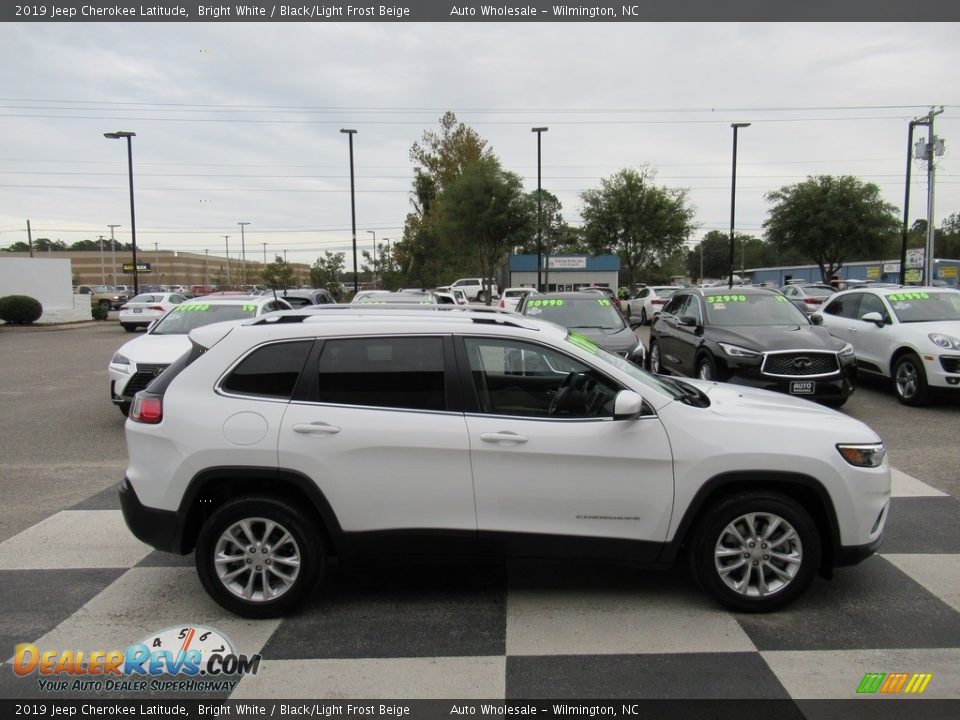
[220,340,313,400]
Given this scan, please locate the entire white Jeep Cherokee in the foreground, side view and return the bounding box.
[119,307,890,617]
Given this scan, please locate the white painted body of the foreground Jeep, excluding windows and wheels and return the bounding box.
[121,309,890,617]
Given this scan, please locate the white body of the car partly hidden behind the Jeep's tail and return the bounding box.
[107,296,290,415]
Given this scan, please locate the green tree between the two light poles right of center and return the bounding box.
[580,168,694,285]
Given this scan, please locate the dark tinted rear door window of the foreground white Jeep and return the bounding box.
[317,338,446,410]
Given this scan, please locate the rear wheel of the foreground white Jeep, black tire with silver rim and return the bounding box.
[196,497,327,618]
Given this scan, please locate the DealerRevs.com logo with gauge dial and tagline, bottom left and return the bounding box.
[13,625,260,692]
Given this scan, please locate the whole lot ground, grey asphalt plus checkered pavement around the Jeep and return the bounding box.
[0,322,960,708]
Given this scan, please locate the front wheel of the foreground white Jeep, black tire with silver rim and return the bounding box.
[690,491,822,613]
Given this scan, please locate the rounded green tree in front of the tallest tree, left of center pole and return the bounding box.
[440,158,530,304]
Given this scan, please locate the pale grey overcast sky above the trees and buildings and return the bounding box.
[0,23,960,272]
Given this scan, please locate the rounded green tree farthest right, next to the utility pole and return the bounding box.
[763,175,900,282]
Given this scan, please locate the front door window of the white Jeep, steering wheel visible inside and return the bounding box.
[464,338,622,419]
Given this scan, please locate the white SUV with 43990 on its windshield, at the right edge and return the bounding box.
[818,287,960,405]
